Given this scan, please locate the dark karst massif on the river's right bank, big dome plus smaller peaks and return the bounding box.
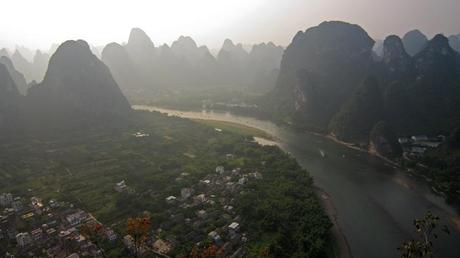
[266,22,460,157]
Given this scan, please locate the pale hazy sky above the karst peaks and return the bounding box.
[0,0,460,49]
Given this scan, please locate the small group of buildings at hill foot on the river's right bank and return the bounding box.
[398,135,446,159]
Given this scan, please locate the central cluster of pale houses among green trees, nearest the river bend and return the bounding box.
[123,163,263,257]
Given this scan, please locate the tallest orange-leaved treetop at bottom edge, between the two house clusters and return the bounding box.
[126,216,152,258]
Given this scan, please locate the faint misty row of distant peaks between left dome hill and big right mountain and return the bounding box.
[102,28,282,94]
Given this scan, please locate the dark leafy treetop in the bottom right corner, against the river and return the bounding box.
[398,211,450,258]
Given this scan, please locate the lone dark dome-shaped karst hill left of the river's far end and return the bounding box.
[27,40,131,124]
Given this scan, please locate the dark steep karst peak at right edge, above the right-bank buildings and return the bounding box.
[401,35,460,133]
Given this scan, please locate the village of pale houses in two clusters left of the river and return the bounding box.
[0,154,263,258]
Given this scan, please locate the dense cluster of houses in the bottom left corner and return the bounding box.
[0,193,116,257]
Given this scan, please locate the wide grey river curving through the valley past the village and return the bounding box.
[133,106,460,258]
